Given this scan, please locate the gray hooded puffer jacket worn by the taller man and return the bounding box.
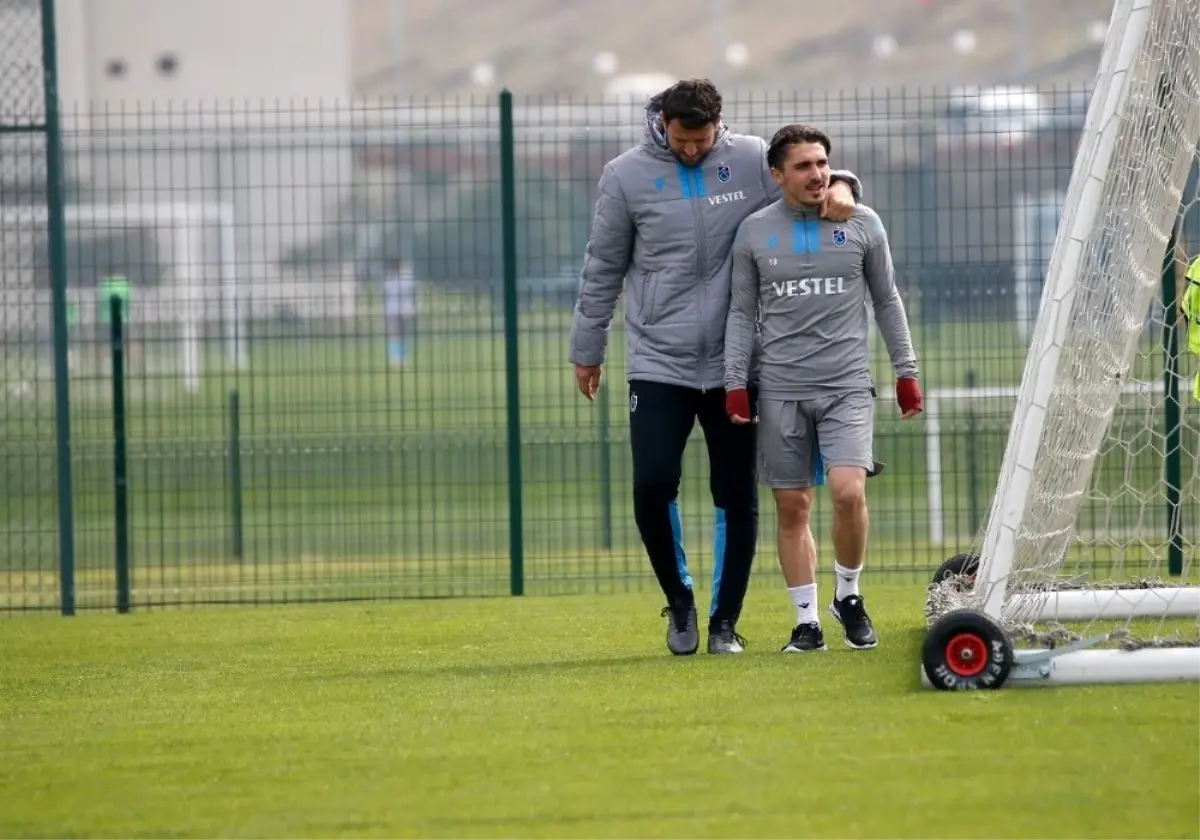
[570,96,862,390]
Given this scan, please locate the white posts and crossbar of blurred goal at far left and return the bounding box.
[0,202,247,392]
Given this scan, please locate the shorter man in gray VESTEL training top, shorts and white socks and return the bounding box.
[725,125,922,653]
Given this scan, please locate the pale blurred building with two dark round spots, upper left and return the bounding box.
[0,0,355,340]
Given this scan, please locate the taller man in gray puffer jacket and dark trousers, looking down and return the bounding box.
[570,79,860,655]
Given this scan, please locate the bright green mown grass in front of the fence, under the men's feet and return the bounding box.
[0,577,1200,840]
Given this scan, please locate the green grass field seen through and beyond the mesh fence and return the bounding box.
[0,294,1200,608]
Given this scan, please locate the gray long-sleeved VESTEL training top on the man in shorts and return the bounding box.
[725,199,917,400]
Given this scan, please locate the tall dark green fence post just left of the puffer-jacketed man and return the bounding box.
[500,90,524,595]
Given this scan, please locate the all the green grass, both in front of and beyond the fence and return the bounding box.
[0,298,1200,840]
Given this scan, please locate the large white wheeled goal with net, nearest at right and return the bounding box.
[923,0,1200,689]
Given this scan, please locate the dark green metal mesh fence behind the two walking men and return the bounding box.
[7,73,1200,610]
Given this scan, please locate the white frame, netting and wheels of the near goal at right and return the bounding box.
[922,0,1200,689]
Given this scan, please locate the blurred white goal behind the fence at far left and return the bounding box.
[0,202,247,392]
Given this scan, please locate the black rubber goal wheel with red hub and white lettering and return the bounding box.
[920,610,1013,691]
